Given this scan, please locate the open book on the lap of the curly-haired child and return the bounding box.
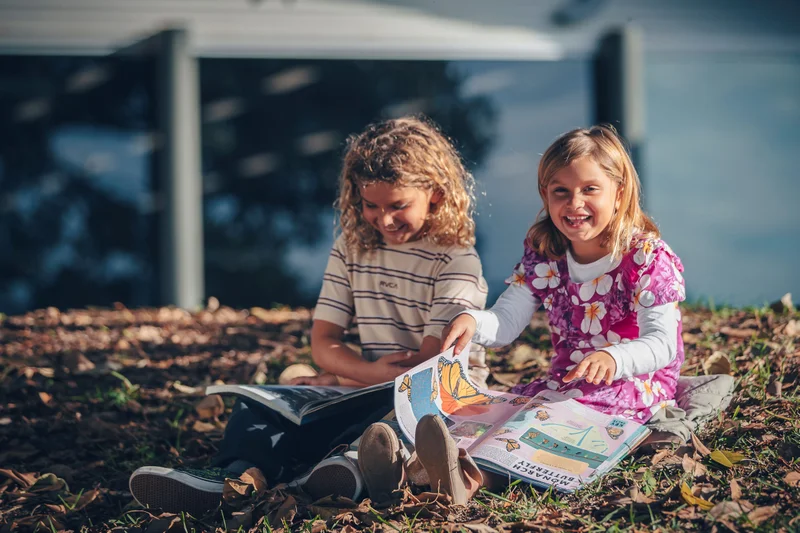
[206,381,392,425]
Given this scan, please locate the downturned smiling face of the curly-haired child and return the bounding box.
[361,182,441,244]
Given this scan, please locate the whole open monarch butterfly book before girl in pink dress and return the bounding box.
[394,346,650,492]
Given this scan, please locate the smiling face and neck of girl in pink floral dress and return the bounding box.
[545,157,619,263]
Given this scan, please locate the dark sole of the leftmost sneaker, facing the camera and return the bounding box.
[130,474,222,517]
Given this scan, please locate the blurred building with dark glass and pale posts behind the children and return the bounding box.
[0,0,800,313]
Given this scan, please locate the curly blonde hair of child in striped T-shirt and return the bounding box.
[336,117,475,250]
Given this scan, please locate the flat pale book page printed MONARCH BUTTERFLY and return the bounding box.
[472,391,642,491]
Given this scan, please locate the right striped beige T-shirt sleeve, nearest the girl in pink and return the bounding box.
[422,248,488,338]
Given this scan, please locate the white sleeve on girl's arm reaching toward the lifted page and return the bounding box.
[462,284,542,348]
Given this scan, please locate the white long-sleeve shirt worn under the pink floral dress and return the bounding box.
[465,252,678,380]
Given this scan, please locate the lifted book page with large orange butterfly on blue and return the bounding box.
[395,345,520,451]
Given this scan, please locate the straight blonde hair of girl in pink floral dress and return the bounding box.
[527,124,660,259]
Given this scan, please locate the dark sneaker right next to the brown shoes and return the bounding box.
[289,451,364,501]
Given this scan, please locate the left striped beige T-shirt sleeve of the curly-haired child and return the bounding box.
[314,237,355,328]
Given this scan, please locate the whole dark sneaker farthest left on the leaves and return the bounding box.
[128,466,231,517]
